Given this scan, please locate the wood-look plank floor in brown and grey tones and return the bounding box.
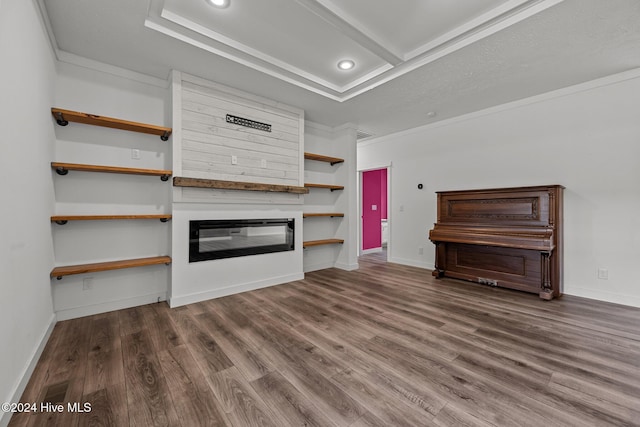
[10,254,640,427]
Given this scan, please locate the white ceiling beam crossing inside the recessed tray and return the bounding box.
[296,0,404,66]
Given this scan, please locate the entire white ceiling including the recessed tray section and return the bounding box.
[41,0,640,140]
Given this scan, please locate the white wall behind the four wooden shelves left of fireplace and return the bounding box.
[51,62,172,320]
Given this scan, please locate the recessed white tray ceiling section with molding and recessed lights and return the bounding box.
[145,0,561,101]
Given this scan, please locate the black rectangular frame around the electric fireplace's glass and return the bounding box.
[189,218,295,263]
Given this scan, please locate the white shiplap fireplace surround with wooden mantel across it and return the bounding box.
[168,72,304,307]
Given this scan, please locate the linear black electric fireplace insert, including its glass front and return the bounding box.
[189,218,294,262]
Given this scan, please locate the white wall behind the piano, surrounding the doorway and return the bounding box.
[358,70,640,307]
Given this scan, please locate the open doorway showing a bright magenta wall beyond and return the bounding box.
[360,168,390,261]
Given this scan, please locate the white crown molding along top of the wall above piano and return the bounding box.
[358,68,640,147]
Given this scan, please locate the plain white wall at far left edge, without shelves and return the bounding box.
[0,0,55,425]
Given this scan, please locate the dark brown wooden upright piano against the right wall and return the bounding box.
[429,185,564,300]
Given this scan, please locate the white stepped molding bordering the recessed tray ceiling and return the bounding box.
[144,0,564,102]
